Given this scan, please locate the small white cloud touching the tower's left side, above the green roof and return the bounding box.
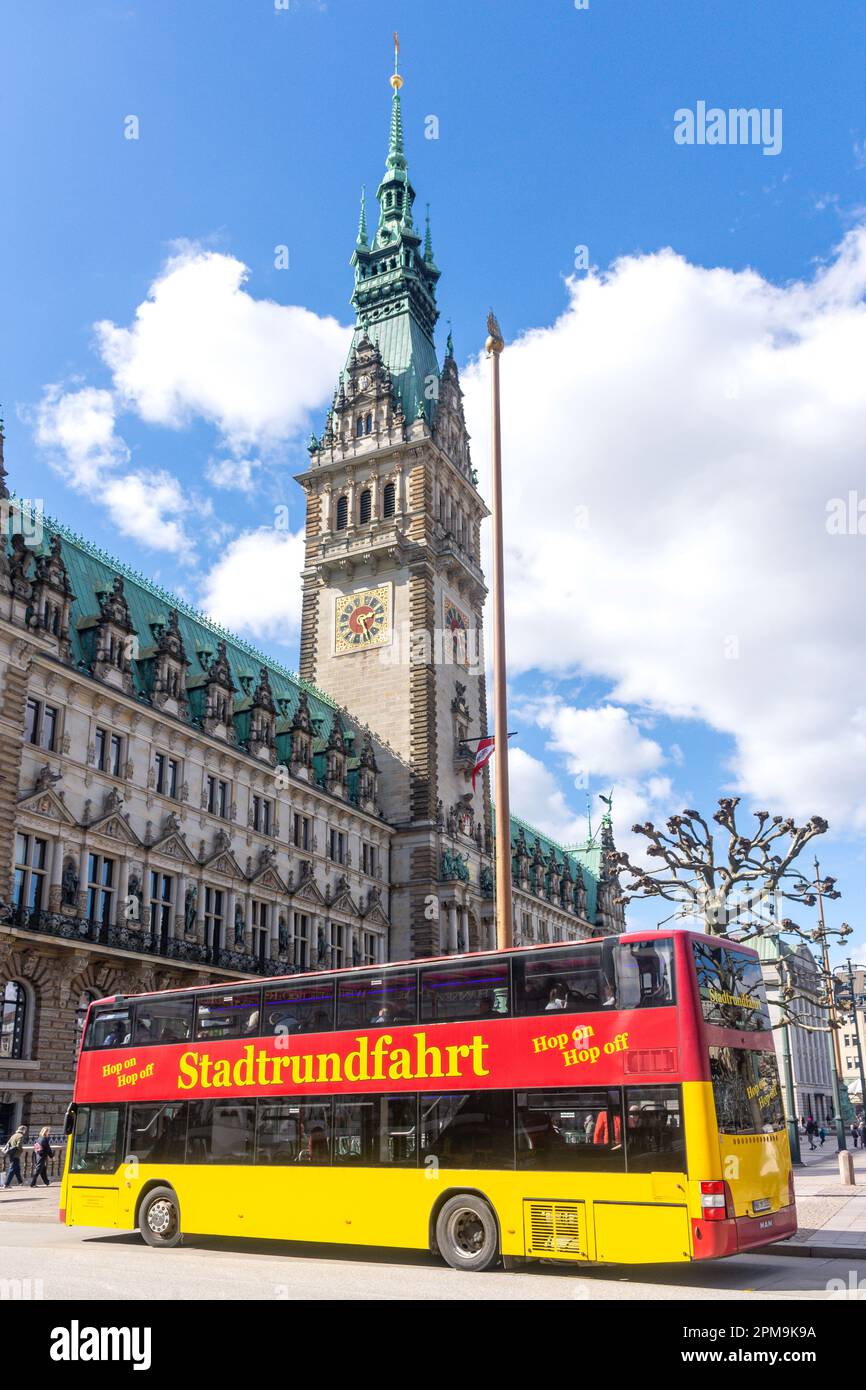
[200,527,304,646]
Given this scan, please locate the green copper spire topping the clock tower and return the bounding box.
[349,35,439,420]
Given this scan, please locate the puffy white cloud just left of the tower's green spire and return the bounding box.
[96,245,350,453]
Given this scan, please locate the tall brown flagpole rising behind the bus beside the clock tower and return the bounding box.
[485,313,514,951]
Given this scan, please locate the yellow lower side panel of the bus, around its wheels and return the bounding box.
[67,1165,700,1264]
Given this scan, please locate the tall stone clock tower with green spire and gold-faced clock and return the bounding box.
[297,46,492,959]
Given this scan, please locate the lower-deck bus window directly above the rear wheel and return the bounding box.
[418,1091,514,1168]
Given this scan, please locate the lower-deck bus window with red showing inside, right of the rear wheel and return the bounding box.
[517,1090,626,1173]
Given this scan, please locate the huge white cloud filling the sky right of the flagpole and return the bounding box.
[463,228,866,827]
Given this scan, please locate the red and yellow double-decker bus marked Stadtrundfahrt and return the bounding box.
[61,931,796,1270]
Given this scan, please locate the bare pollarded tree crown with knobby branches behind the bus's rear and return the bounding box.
[606,796,827,935]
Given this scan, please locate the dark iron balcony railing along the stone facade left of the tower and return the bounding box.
[0,904,296,976]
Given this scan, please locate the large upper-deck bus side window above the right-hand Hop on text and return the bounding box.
[513,941,616,1015]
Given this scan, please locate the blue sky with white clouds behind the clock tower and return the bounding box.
[0,0,866,952]
